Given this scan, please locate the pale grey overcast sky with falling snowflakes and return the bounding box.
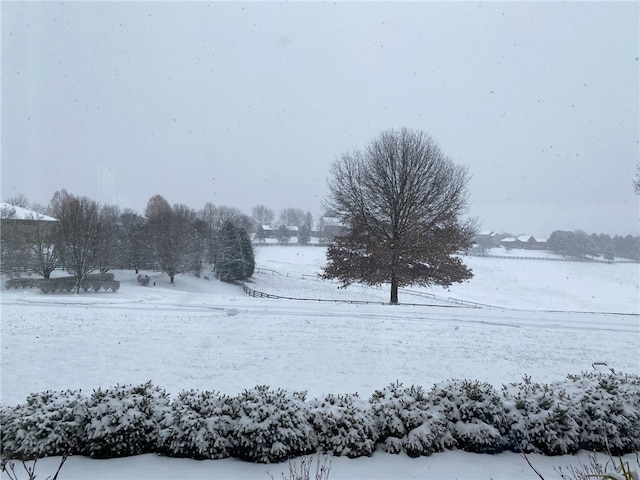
[1,2,640,236]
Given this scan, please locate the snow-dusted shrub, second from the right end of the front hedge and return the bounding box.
[503,376,580,455]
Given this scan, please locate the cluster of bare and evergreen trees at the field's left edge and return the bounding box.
[1,189,264,291]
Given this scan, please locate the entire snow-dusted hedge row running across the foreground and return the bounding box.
[0,373,640,463]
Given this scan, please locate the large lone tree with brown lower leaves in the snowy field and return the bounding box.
[324,128,476,304]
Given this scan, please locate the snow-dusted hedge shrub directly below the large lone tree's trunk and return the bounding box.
[369,382,452,457]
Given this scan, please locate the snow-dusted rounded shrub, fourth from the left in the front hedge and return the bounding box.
[233,385,318,463]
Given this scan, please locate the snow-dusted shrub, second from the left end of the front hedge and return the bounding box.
[85,382,169,458]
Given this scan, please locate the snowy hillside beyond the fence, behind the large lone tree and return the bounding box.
[251,247,640,314]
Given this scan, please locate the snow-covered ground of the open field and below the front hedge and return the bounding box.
[0,246,640,479]
